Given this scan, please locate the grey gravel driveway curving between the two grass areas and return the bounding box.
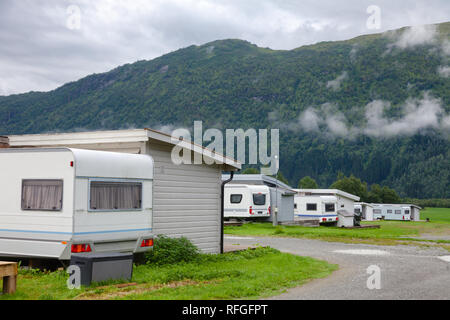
[225,236,450,300]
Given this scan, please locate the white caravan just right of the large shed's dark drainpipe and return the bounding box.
[224,184,271,219]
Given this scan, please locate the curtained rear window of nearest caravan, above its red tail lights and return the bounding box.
[89,181,142,211]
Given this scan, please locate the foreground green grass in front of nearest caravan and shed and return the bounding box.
[0,248,337,300]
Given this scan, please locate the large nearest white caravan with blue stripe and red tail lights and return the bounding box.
[0,148,154,260]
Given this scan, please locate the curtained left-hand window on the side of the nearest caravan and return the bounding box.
[22,179,63,211]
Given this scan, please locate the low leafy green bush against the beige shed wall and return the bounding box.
[145,236,200,266]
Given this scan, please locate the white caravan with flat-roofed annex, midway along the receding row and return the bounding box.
[294,189,359,224]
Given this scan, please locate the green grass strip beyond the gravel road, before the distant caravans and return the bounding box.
[225,208,450,250]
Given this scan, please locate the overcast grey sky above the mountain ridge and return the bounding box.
[0,0,450,95]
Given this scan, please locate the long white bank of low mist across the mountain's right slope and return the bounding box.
[276,92,450,139]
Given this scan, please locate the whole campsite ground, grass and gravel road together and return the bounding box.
[0,209,450,300]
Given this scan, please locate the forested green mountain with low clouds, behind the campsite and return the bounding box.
[0,23,450,198]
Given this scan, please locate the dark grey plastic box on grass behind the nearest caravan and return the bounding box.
[70,253,133,286]
